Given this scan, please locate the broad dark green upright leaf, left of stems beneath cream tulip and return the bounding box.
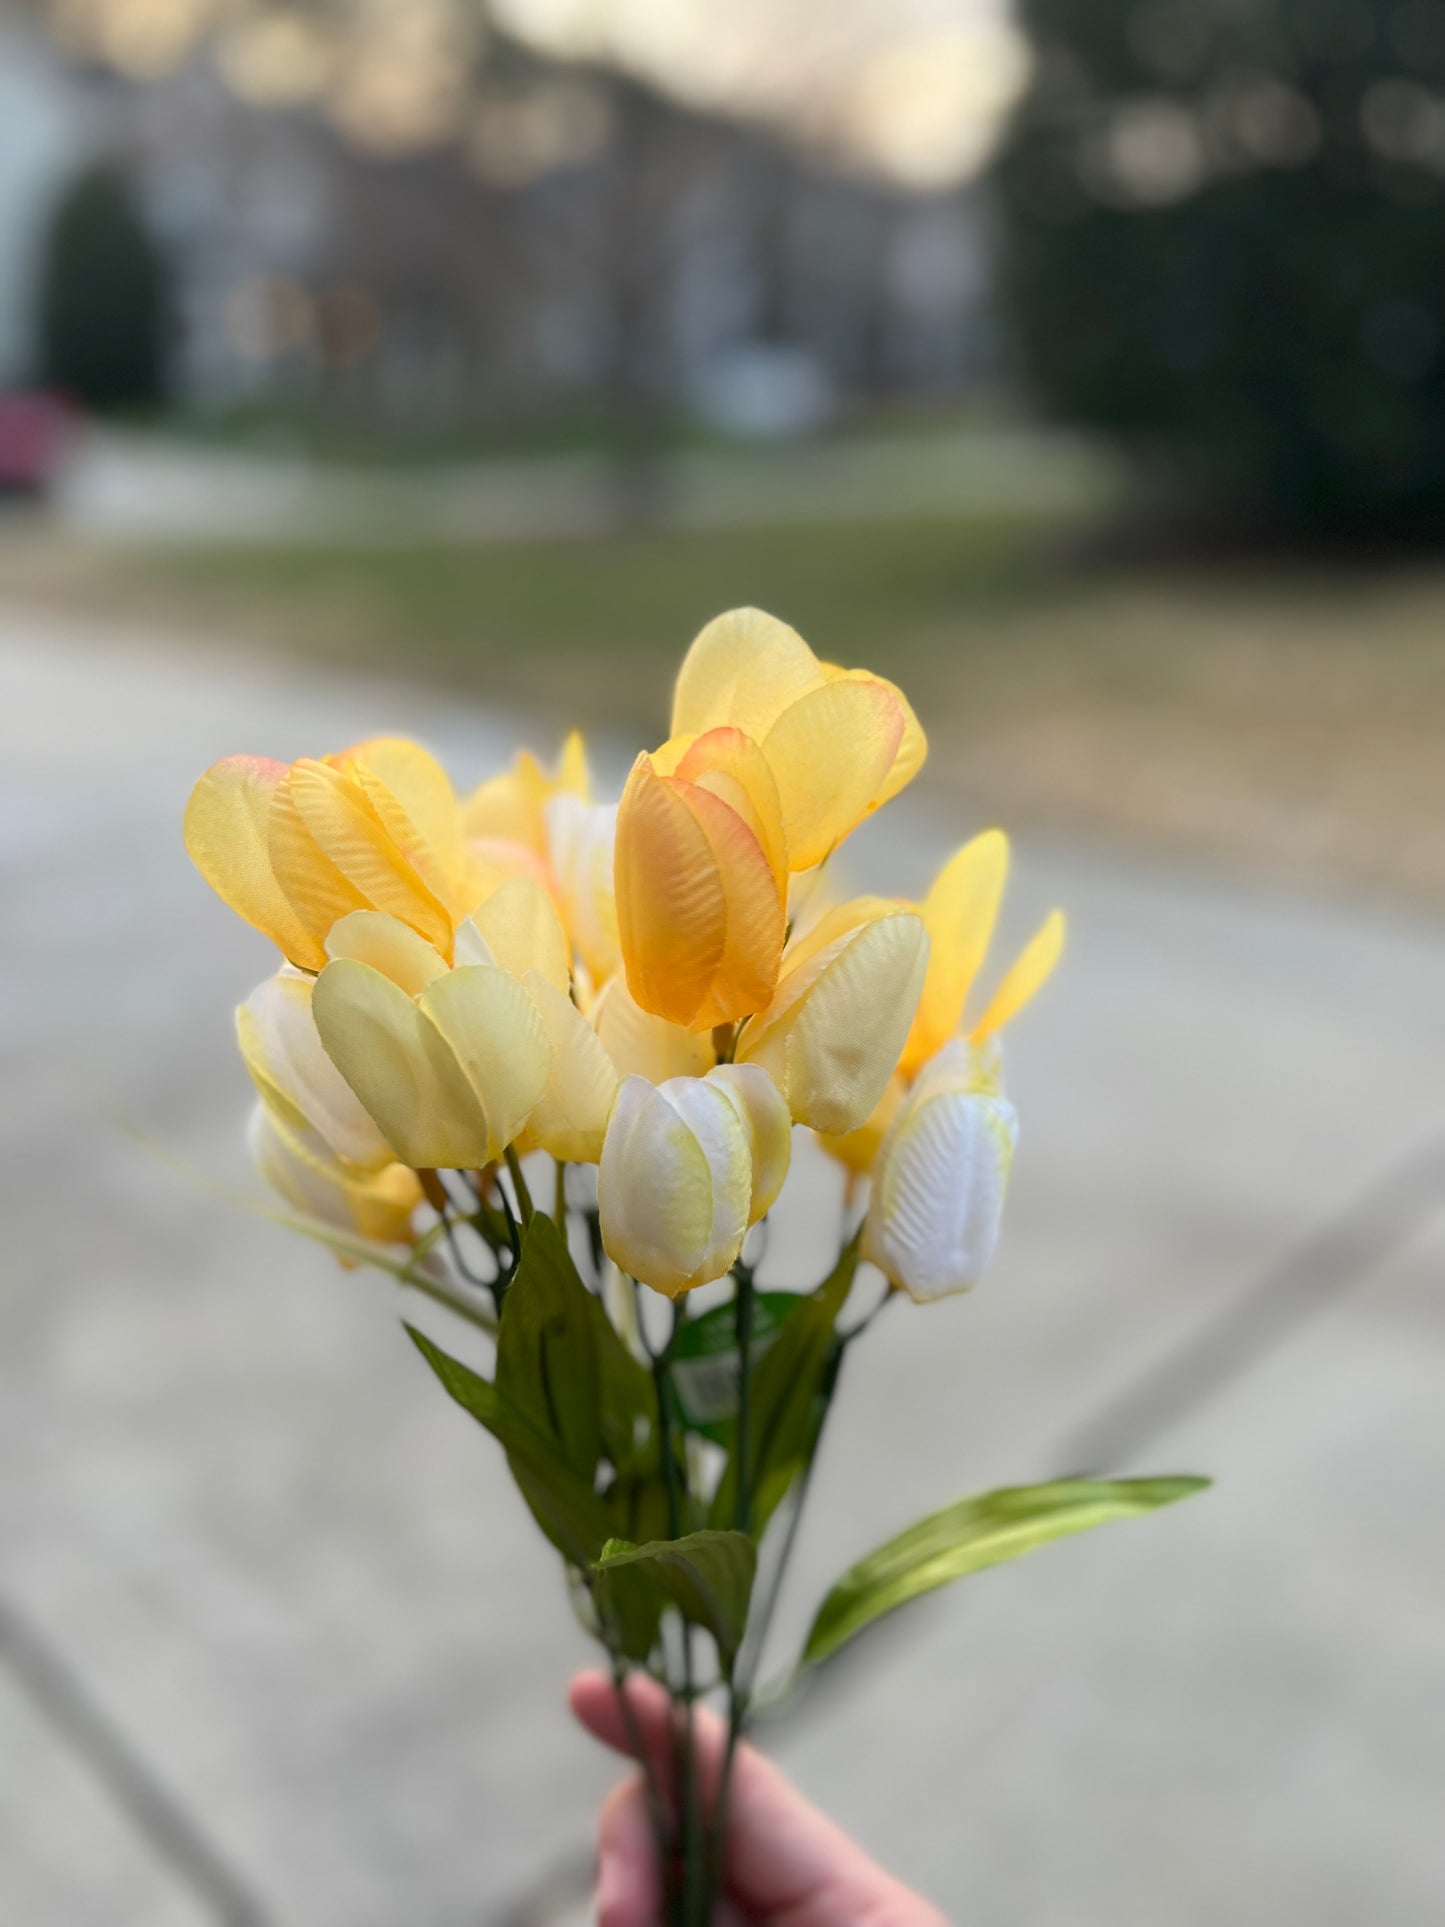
[497,1212,601,1484]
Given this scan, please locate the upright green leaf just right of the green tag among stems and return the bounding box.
[709,1239,859,1538]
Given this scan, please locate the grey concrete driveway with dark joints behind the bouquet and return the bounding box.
[0,611,1445,1927]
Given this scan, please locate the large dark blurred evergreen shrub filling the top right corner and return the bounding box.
[1000,0,1445,536]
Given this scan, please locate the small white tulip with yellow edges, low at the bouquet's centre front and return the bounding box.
[597,1066,788,1297]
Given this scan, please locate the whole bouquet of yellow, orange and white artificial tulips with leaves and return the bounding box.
[185,609,1200,1927]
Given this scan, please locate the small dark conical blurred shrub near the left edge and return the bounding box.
[39,168,170,410]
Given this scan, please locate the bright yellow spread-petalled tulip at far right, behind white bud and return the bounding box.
[900,831,1064,1077]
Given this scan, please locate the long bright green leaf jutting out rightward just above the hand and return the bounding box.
[801,1478,1210,1667]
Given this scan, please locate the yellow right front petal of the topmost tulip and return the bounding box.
[763,676,904,869]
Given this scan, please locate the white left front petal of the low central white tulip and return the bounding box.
[597,1077,713,1297]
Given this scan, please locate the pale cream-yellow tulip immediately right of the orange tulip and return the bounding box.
[736,898,929,1137]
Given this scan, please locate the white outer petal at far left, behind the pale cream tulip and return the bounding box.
[235,971,393,1170]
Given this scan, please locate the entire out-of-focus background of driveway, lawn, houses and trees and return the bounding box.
[0,0,1445,1927]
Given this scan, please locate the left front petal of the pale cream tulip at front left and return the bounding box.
[312,958,497,1170]
